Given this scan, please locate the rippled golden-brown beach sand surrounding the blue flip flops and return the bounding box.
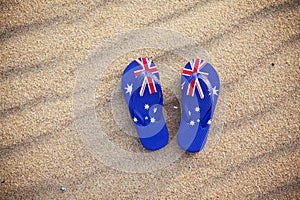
[0,0,300,199]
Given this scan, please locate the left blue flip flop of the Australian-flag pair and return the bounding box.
[122,58,169,150]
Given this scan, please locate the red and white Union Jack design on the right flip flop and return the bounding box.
[182,58,208,99]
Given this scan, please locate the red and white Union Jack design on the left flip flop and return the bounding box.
[134,58,158,96]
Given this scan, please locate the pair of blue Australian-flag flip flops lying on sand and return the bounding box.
[122,58,220,152]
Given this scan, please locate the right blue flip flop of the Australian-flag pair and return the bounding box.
[178,58,220,152]
